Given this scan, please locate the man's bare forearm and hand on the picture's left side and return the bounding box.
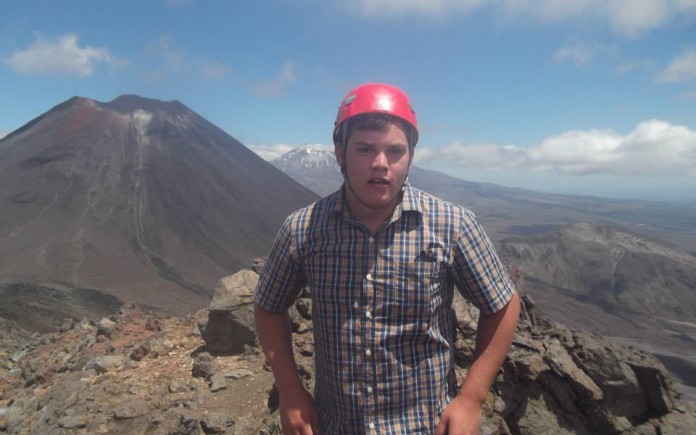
[254,303,319,435]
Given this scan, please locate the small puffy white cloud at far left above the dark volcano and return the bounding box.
[3,34,124,77]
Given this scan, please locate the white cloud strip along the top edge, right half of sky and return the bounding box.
[336,0,696,37]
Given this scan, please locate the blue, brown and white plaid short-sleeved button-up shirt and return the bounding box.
[255,185,515,434]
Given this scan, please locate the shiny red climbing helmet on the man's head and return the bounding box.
[334,83,418,146]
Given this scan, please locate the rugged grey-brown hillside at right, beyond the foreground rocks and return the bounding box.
[498,224,696,385]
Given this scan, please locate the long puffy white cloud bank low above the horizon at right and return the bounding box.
[431,120,696,177]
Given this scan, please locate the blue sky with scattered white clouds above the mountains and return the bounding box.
[0,0,696,201]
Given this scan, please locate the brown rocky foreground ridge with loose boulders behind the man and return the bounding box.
[0,261,696,434]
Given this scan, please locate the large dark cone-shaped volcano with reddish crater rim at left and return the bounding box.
[0,96,316,312]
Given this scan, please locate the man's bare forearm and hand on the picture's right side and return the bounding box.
[437,292,520,435]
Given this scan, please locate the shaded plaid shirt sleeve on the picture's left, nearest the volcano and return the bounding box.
[254,216,306,313]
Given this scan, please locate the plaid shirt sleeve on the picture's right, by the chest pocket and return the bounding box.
[452,210,515,314]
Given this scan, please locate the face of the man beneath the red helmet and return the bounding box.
[335,124,410,209]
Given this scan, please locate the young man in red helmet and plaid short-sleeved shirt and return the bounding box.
[255,83,519,435]
